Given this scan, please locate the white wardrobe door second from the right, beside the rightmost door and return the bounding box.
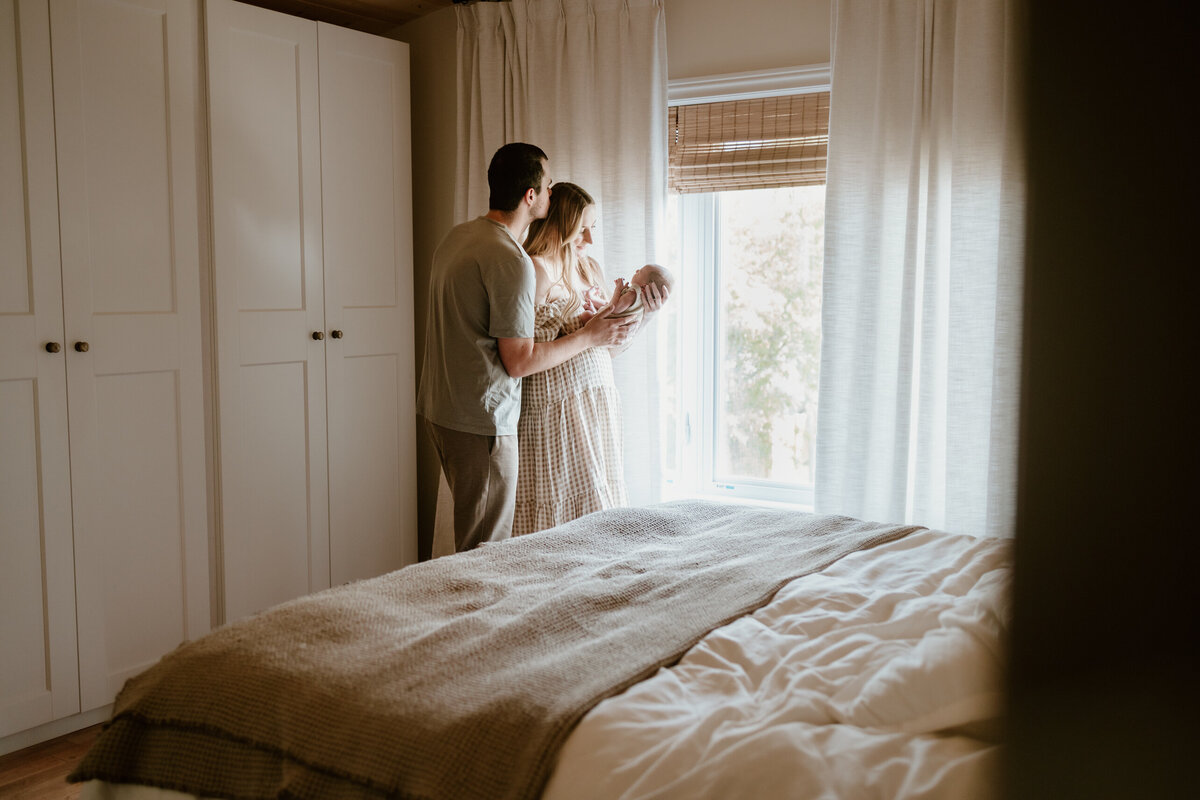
[208,0,329,620]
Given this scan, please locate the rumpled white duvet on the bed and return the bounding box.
[82,531,1010,800]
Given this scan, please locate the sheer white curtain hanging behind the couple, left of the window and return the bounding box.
[434,0,667,553]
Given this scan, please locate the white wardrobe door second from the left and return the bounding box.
[50,0,210,710]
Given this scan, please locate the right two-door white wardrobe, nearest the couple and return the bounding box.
[208,0,416,620]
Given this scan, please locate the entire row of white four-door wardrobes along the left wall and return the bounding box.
[0,0,416,753]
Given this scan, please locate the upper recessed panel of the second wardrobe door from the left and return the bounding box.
[64,0,175,315]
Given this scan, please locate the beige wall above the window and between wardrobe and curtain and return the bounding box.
[394,0,829,557]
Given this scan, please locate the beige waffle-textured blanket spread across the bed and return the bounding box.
[71,501,914,800]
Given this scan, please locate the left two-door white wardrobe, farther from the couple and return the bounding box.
[0,0,210,736]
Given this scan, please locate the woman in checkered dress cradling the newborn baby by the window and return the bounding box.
[512,184,667,536]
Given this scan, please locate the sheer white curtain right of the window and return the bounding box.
[815,0,1024,535]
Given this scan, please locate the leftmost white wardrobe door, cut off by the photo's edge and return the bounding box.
[0,0,79,736]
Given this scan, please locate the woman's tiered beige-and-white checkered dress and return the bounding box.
[512,299,626,536]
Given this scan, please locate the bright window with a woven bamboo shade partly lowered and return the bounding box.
[659,77,829,506]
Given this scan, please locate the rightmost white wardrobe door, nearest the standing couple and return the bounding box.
[318,23,416,584]
